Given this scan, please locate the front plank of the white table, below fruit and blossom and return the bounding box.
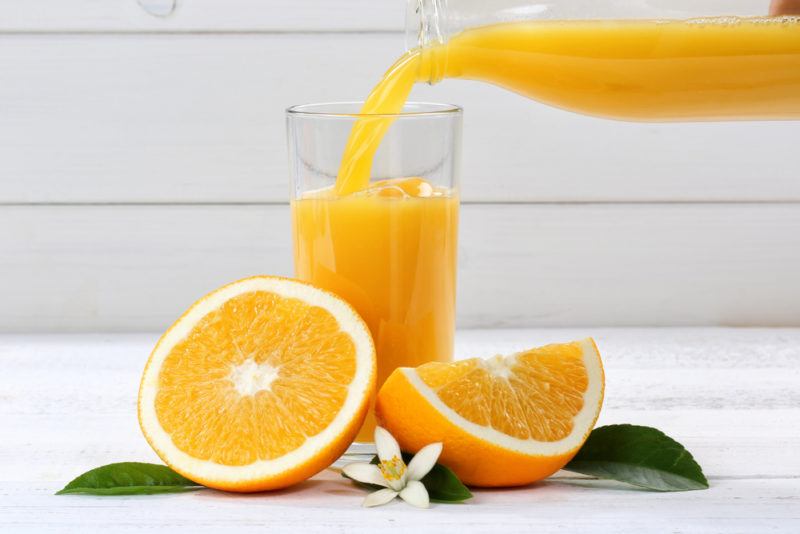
[0,480,800,534]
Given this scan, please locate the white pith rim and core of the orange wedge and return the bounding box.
[400,339,603,456]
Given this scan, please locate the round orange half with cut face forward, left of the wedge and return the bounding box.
[139,276,376,491]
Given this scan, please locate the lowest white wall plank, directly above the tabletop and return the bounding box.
[0,204,800,331]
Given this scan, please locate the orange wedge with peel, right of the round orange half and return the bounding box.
[375,339,604,487]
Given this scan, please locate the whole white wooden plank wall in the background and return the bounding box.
[0,0,800,331]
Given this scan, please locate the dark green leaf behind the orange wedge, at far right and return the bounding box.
[564,425,708,491]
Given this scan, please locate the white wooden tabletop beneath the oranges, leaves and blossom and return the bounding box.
[0,328,800,533]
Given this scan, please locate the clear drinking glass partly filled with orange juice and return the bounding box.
[287,102,462,443]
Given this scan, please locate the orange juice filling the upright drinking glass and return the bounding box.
[292,178,458,441]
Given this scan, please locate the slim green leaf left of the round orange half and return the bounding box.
[56,462,203,495]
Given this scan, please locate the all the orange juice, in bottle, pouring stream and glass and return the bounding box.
[318,16,800,439]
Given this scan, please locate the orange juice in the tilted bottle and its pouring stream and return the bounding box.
[336,16,800,194]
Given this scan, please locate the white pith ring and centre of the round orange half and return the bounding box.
[139,277,375,483]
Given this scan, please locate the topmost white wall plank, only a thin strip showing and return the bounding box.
[0,0,768,32]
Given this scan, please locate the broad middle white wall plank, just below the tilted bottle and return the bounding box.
[0,32,800,203]
